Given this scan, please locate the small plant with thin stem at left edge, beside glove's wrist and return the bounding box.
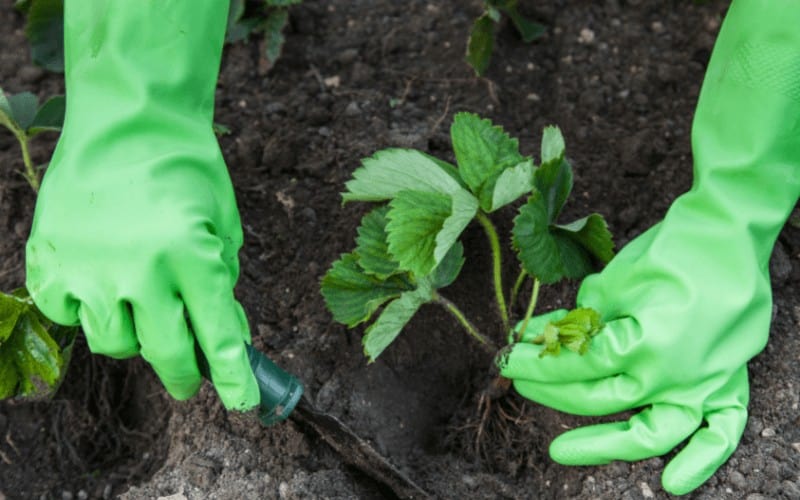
[0,88,65,192]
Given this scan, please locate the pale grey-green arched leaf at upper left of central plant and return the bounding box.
[342,149,462,203]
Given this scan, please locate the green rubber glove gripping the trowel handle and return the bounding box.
[27,0,259,410]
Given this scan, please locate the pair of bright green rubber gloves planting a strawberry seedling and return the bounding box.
[27,0,800,494]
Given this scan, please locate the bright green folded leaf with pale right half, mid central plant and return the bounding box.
[386,190,478,277]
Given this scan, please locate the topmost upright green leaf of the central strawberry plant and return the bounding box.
[450,113,525,211]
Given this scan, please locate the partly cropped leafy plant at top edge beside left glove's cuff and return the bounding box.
[225,0,303,72]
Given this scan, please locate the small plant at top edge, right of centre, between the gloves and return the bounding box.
[467,0,545,76]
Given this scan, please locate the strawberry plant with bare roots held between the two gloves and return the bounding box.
[321,113,613,361]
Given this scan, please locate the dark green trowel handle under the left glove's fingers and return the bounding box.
[196,344,303,425]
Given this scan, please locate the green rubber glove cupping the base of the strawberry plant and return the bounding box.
[498,0,800,494]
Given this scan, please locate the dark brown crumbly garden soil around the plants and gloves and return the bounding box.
[0,0,800,500]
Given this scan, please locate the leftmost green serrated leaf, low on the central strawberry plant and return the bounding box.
[322,253,414,328]
